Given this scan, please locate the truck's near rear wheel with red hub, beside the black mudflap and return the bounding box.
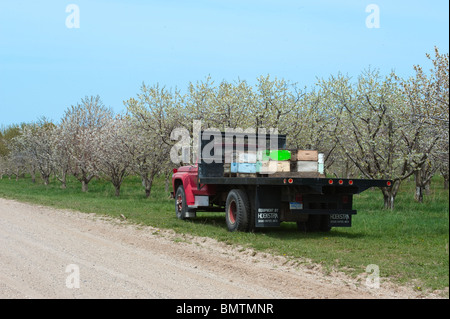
[225,189,250,232]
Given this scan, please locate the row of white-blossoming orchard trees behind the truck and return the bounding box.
[0,48,449,209]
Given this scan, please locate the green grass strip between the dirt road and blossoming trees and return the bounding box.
[0,177,449,296]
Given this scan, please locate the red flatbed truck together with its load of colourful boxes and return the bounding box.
[172,131,392,231]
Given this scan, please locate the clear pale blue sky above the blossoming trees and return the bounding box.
[0,0,449,126]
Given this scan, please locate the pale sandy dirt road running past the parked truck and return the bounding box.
[0,198,438,299]
